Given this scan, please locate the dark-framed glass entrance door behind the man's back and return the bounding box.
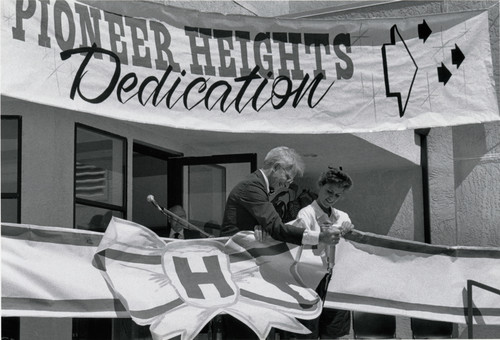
[168,154,257,236]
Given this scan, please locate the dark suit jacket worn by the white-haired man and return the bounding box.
[221,170,304,244]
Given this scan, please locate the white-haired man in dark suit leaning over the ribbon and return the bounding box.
[221,146,340,339]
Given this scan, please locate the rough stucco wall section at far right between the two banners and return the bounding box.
[452,124,500,247]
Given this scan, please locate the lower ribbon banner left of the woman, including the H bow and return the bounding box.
[2,218,325,339]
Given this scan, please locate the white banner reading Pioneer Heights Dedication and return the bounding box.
[1,0,499,133]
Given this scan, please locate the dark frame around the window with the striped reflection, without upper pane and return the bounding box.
[73,123,128,228]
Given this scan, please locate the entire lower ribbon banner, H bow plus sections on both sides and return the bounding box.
[2,218,500,339]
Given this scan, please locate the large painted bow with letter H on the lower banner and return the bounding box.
[95,218,324,339]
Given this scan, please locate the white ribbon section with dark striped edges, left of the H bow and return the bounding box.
[1,223,129,318]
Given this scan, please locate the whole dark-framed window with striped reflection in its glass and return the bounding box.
[74,124,127,232]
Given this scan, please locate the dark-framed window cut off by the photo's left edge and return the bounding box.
[2,116,21,223]
